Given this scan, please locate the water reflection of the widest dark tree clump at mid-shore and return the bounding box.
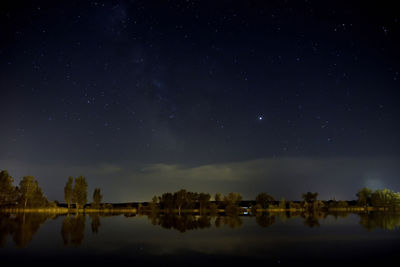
[148,213,211,232]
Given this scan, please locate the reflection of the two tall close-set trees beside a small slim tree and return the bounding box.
[61,214,86,247]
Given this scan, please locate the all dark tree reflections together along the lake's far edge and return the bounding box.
[0,212,400,248]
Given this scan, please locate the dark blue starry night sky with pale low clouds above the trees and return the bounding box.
[0,0,400,202]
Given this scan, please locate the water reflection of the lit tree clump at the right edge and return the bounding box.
[359,212,400,231]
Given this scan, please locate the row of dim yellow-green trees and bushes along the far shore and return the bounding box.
[0,170,400,214]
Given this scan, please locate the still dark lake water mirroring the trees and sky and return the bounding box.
[0,212,400,266]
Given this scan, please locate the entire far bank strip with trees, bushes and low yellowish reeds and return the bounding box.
[0,170,400,216]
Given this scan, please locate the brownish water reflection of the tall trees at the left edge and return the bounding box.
[0,213,52,247]
